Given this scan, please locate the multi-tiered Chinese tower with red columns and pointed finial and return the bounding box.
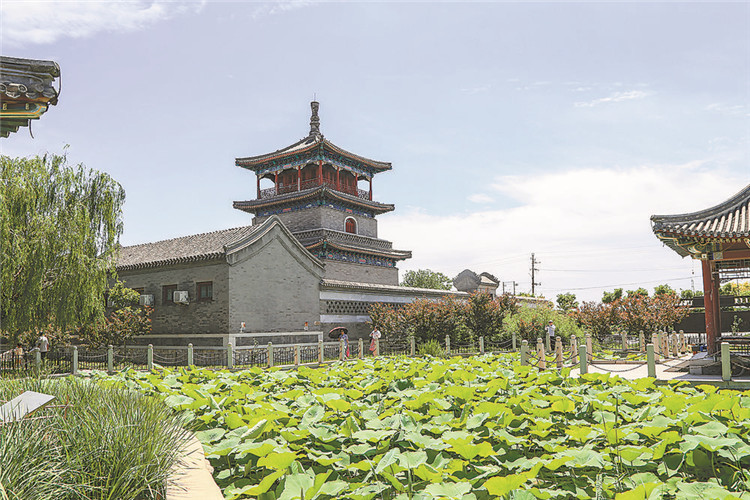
[234,102,411,285]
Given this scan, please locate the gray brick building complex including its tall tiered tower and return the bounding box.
[117,102,466,338]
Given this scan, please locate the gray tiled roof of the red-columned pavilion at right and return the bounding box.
[651,185,750,238]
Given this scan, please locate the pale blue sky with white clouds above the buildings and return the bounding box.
[0,0,750,300]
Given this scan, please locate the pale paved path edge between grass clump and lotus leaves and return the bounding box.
[166,436,224,500]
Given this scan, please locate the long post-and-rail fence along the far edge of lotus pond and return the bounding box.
[0,333,736,375]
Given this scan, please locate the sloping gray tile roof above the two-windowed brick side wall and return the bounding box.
[117,226,260,271]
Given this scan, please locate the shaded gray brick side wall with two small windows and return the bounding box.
[119,260,229,334]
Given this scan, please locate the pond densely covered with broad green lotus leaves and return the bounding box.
[100,355,750,500]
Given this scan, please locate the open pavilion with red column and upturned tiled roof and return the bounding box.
[651,185,750,353]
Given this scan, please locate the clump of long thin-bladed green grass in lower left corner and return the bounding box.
[0,379,186,500]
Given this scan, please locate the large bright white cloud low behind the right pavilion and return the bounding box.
[379,162,745,300]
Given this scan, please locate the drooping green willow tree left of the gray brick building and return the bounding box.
[0,155,125,338]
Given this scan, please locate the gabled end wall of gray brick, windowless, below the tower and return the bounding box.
[229,227,323,332]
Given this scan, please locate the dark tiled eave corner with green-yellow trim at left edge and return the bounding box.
[0,56,60,137]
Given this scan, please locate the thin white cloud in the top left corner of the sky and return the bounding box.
[0,0,205,47]
